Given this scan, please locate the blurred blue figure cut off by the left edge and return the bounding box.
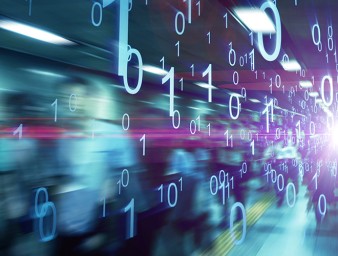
[0,92,50,255]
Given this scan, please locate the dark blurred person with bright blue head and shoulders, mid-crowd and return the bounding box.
[155,139,210,255]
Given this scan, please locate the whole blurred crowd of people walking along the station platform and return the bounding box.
[0,77,337,256]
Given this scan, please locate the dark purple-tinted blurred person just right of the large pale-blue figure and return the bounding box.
[117,105,173,255]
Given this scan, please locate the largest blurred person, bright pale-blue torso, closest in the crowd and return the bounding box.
[51,77,146,255]
